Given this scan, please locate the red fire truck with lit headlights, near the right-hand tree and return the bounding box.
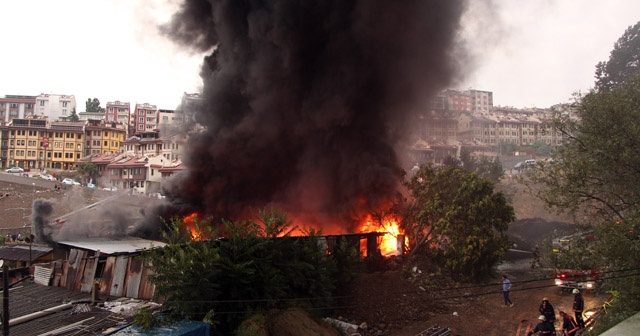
[553,232,600,290]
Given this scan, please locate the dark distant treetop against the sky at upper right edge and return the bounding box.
[596,22,640,90]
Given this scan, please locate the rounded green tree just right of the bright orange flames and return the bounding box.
[401,165,515,280]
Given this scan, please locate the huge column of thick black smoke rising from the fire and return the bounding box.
[164,0,464,229]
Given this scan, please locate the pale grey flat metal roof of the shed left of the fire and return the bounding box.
[58,238,167,254]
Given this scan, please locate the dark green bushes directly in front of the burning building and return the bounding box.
[145,209,357,334]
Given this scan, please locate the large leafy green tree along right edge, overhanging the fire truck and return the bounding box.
[529,76,640,334]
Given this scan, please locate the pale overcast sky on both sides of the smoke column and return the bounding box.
[0,0,640,111]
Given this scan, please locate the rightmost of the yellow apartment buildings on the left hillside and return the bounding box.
[84,120,127,156]
